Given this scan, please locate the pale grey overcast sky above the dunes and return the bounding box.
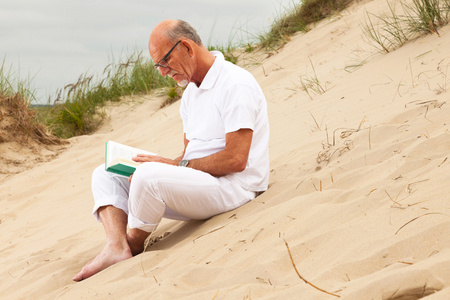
[0,0,299,104]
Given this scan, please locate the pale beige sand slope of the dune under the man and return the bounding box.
[0,0,450,299]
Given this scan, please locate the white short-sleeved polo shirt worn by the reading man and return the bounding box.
[180,51,269,192]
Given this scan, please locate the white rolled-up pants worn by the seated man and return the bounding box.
[92,162,255,232]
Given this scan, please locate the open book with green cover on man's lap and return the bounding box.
[105,141,156,176]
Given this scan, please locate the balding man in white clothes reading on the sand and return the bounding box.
[73,20,269,281]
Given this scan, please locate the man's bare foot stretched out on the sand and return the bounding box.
[72,244,132,281]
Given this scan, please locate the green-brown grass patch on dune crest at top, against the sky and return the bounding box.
[259,0,352,49]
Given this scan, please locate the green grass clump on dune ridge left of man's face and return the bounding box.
[39,53,173,138]
